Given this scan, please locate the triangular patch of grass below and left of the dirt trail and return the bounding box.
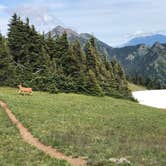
[0,108,67,166]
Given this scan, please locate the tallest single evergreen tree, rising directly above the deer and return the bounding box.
[8,14,30,82]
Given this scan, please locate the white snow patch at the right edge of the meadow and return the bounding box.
[132,90,166,109]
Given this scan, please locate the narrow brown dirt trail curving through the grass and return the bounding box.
[0,101,87,166]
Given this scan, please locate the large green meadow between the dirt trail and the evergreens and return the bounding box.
[0,88,166,166]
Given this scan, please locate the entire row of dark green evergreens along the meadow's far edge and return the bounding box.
[0,14,131,98]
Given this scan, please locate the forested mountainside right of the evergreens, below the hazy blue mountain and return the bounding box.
[110,42,166,88]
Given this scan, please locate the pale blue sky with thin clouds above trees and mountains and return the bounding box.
[0,0,166,46]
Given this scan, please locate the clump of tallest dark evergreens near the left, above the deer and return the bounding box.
[8,14,50,85]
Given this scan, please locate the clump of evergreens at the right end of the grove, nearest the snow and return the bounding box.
[85,38,130,97]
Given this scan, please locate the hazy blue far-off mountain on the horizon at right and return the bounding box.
[123,34,166,46]
